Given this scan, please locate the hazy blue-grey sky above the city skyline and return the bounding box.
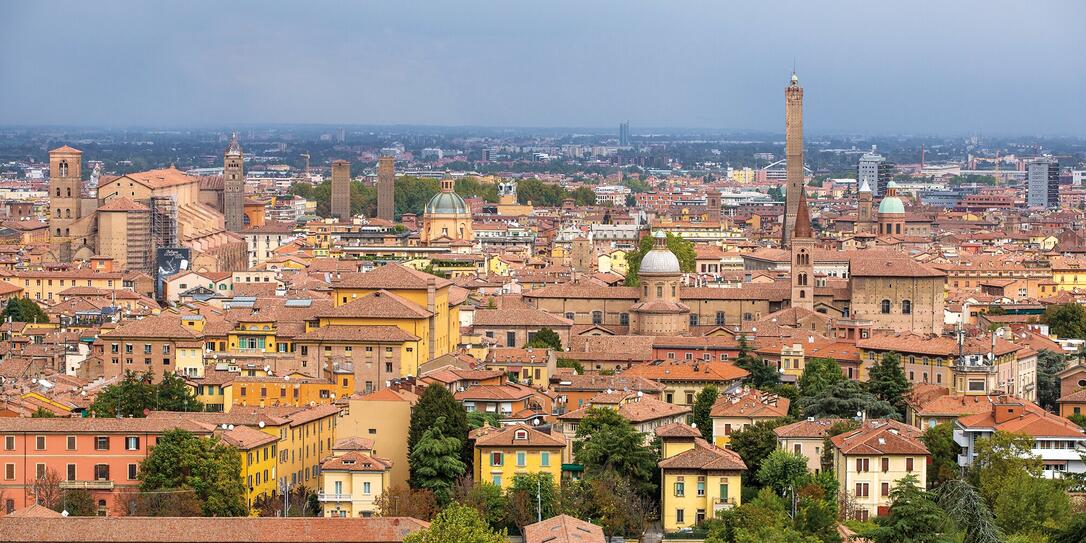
[0,0,1086,136]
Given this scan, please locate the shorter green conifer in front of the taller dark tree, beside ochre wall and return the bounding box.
[409,414,467,504]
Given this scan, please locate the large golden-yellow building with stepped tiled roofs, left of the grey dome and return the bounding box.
[317,264,466,376]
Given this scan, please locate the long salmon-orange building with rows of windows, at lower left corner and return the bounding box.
[0,418,212,515]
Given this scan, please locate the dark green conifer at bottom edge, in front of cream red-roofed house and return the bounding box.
[863,473,950,543]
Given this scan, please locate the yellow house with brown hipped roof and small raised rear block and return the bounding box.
[656,422,746,532]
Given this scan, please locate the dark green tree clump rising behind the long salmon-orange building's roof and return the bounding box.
[90,371,203,417]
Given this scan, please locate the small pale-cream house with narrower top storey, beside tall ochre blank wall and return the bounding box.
[317,438,392,517]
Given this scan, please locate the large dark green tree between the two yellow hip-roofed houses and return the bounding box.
[573,407,657,495]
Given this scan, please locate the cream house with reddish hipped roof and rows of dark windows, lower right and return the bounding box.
[831,419,930,520]
